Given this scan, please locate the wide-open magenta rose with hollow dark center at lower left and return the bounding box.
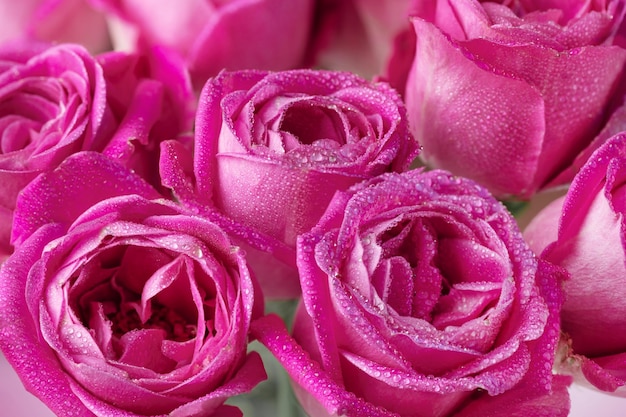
[0,152,265,416]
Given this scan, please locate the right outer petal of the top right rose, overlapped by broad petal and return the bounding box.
[464,40,626,185]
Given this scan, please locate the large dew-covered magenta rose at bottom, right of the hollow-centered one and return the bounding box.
[253,170,569,417]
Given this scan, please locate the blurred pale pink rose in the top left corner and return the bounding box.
[0,0,110,53]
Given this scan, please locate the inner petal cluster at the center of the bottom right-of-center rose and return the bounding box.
[366,216,502,329]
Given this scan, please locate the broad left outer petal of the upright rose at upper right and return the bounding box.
[406,18,546,194]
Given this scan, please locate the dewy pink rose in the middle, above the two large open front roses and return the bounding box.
[162,70,418,296]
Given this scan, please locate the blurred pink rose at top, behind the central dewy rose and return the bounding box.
[91,0,314,88]
